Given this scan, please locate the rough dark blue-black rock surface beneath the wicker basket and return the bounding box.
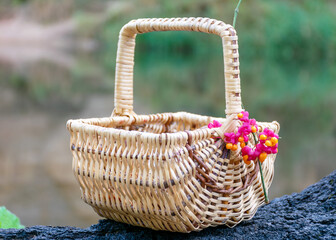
[0,171,336,240]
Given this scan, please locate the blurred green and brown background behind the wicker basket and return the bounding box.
[0,0,336,227]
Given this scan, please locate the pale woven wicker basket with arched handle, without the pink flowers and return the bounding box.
[67,18,280,232]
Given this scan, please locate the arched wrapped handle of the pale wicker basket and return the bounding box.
[112,18,242,116]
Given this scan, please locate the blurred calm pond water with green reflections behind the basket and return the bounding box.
[0,33,336,227]
